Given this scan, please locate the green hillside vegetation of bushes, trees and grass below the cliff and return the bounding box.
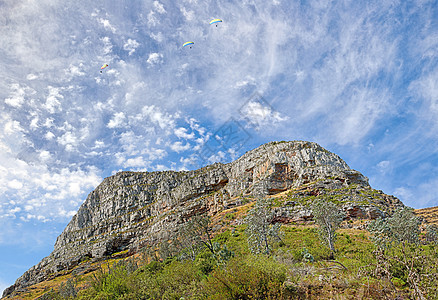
[21,201,438,300]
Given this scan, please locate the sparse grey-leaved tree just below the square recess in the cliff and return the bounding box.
[246,199,281,254]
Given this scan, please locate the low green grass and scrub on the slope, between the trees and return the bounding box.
[11,223,428,299]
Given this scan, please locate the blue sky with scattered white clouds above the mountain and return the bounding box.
[0,0,438,290]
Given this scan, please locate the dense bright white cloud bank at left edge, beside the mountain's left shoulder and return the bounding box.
[0,145,101,221]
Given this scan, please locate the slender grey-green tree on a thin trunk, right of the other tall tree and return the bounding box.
[312,200,344,259]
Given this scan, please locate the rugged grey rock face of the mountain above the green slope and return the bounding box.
[3,141,403,297]
